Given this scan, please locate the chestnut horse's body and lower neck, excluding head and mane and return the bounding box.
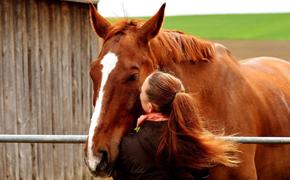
[151,32,290,179]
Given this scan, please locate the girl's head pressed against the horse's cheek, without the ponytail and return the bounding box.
[140,71,184,115]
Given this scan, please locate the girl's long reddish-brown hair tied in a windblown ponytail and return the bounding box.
[145,71,239,176]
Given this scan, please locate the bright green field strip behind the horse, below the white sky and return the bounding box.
[109,13,290,40]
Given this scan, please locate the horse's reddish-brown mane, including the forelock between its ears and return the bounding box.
[105,19,215,63]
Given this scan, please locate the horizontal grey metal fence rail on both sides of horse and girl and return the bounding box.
[0,134,290,144]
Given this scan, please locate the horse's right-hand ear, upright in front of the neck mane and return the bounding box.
[140,3,166,42]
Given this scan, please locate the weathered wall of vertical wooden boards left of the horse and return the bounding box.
[0,0,98,180]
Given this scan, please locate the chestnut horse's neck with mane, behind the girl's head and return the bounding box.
[150,32,246,108]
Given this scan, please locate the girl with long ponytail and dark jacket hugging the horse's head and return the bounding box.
[114,71,239,180]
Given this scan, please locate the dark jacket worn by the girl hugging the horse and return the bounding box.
[113,121,208,180]
